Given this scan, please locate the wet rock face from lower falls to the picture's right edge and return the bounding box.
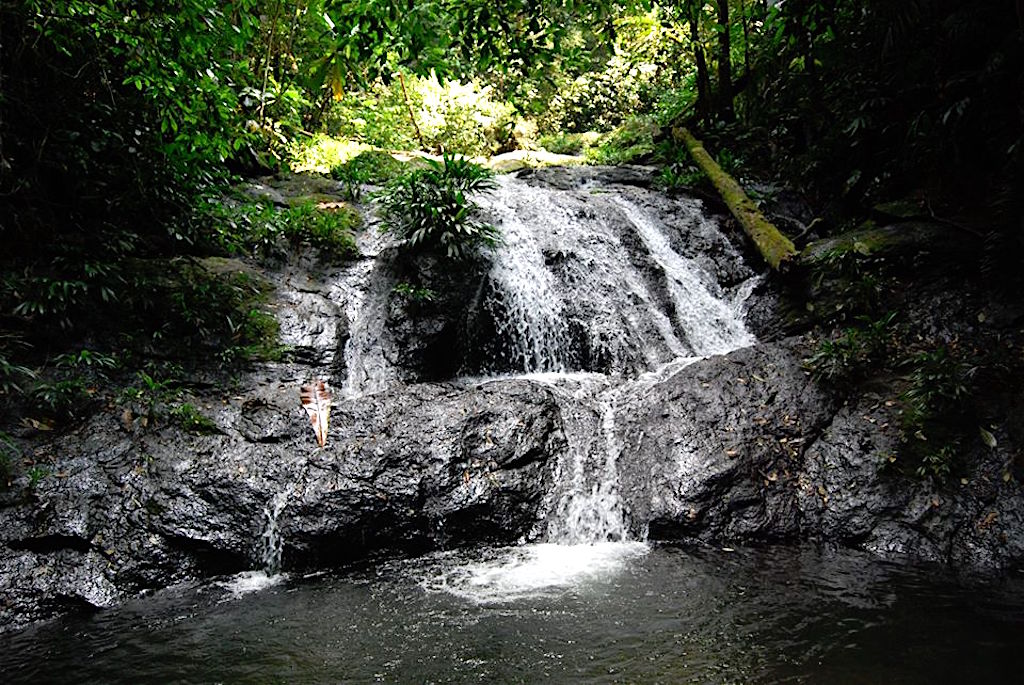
[620,340,1024,572]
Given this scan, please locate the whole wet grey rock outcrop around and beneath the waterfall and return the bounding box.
[0,169,1024,629]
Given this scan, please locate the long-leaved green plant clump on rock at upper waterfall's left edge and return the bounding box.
[380,155,498,259]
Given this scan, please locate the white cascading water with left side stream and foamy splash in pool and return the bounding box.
[344,172,756,602]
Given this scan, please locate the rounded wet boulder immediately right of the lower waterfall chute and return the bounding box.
[621,344,830,541]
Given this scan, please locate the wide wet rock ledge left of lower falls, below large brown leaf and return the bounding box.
[0,381,564,624]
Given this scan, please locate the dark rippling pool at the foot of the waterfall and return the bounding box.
[0,547,1024,684]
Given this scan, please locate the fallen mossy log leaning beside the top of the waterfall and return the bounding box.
[672,127,798,271]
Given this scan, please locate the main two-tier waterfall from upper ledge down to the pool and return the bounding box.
[468,177,756,545]
